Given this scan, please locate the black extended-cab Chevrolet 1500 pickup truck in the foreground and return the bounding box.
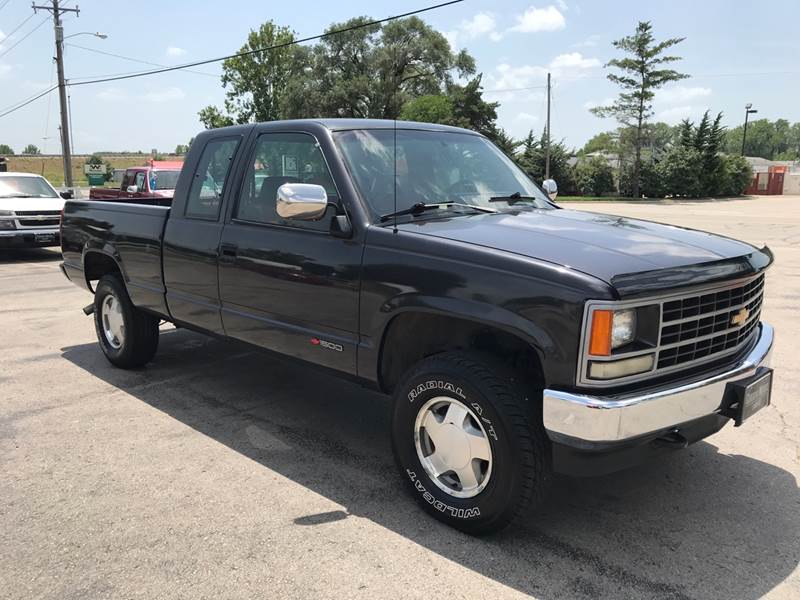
[61,119,773,533]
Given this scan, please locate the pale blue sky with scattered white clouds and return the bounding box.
[0,0,800,153]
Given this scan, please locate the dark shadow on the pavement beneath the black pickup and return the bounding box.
[62,330,800,599]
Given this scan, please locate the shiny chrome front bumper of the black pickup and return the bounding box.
[544,322,774,444]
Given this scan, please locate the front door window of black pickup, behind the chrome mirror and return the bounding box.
[234,133,339,231]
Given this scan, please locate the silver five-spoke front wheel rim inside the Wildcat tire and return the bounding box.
[414,396,492,498]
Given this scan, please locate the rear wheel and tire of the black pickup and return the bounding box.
[94,275,159,369]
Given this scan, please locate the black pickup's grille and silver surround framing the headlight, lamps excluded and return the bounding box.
[577,273,764,387]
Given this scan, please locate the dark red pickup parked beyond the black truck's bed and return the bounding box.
[89,161,183,206]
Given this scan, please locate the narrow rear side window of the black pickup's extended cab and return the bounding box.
[185,138,239,221]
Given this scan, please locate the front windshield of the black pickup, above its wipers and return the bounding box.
[335,129,552,220]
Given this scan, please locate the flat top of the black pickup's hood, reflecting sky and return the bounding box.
[398,209,755,284]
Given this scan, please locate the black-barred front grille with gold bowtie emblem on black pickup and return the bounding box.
[657,275,764,369]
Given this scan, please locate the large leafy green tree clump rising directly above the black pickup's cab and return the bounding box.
[205,17,480,127]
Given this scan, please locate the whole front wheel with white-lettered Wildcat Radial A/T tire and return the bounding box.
[392,352,551,535]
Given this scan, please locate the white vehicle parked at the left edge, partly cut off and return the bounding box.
[0,173,70,248]
